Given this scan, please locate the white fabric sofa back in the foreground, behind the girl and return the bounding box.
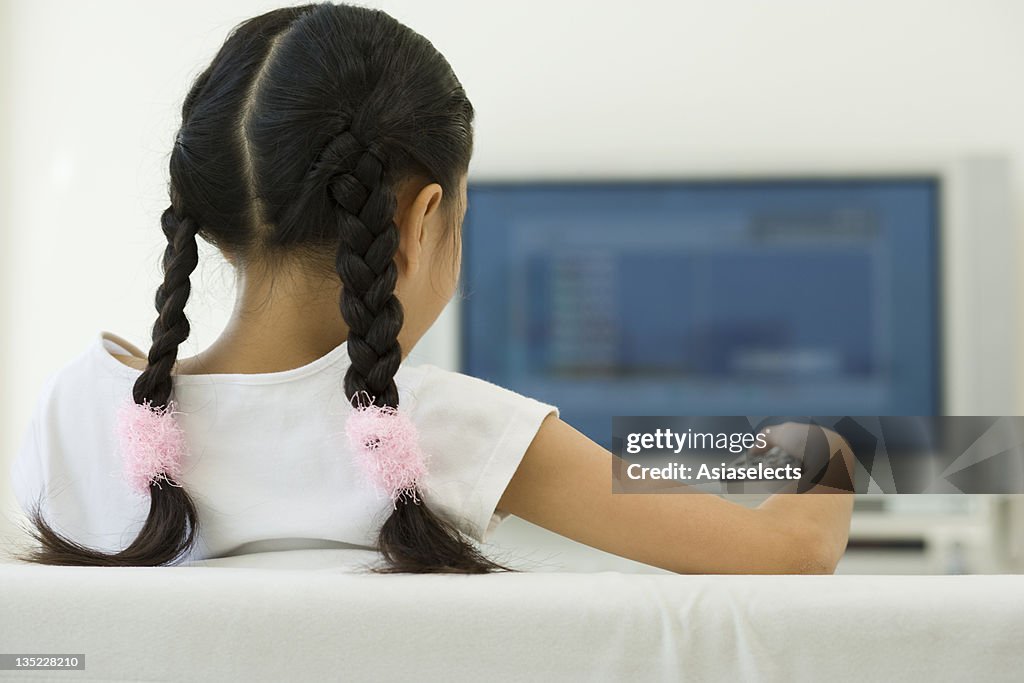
[0,550,1024,682]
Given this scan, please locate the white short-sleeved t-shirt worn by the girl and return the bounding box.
[11,332,558,560]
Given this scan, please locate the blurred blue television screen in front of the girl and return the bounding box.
[461,178,940,445]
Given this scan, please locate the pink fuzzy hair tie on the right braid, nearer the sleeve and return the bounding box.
[345,395,427,507]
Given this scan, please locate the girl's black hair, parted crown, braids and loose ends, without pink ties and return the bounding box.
[24,3,508,573]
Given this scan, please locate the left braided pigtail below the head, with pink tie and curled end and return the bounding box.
[22,207,199,566]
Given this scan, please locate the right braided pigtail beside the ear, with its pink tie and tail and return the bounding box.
[322,131,508,573]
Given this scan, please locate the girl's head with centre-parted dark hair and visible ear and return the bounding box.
[192,4,473,362]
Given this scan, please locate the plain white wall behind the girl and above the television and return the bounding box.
[0,0,1024,544]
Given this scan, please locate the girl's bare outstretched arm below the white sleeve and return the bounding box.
[498,415,853,573]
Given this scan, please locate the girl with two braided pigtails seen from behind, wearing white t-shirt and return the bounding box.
[13,4,851,573]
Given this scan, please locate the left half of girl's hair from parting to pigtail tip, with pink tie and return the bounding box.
[12,6,311,566]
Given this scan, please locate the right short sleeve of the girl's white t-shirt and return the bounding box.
[412,366,558,542]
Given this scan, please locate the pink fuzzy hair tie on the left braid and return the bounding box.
[117,398,187,495]
